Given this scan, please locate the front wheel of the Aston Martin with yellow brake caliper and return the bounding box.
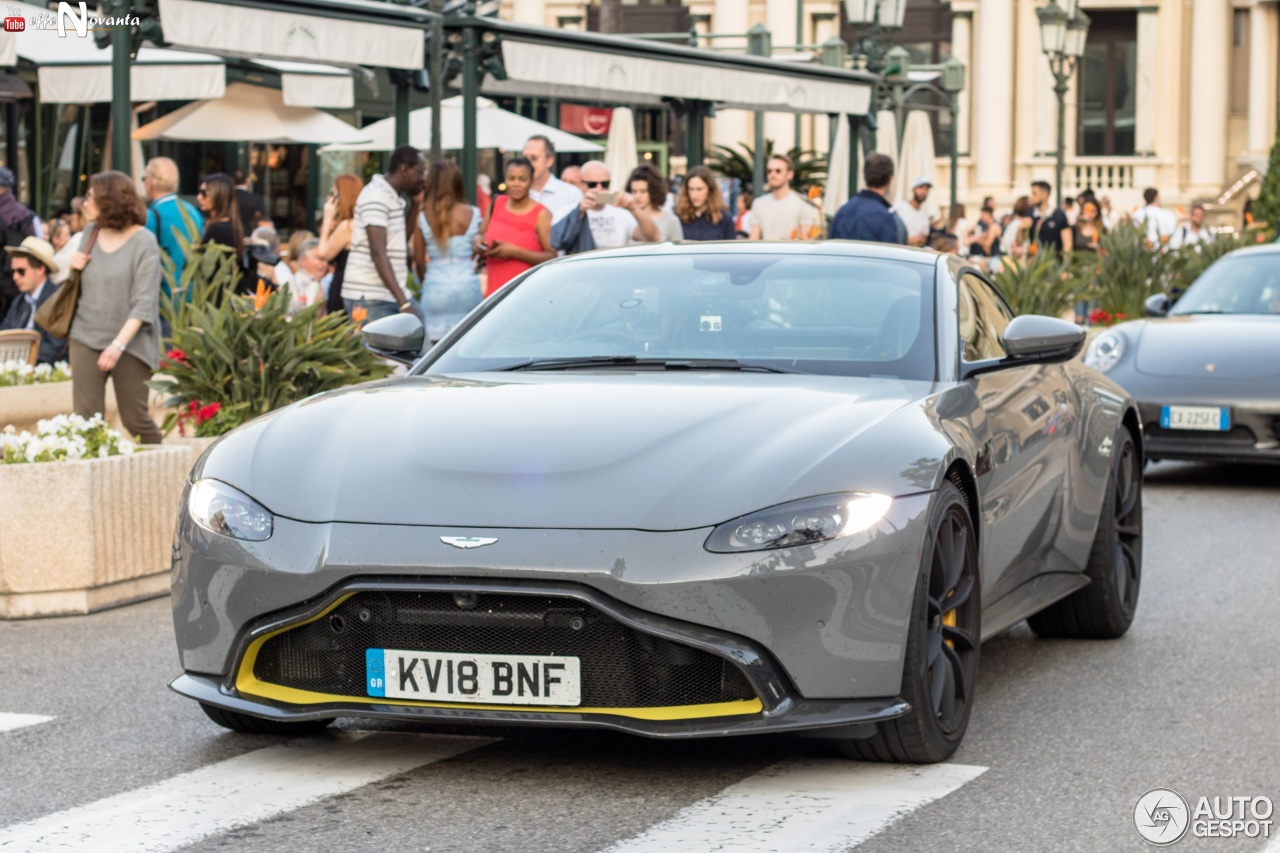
[836,482,982,765]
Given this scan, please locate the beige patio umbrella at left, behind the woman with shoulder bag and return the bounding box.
[133,83,367,143]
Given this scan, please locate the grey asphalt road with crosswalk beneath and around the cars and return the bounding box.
[0,462,1280,853]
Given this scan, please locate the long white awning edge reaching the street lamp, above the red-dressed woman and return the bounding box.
[481,36,872,115]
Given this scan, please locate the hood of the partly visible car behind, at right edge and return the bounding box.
[1134,314,1280,379]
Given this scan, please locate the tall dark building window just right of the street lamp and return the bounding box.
[1076,10,1138,158]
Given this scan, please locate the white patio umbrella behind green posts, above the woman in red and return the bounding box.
[320,96,600,154]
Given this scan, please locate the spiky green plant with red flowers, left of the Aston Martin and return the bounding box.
[151,239,390,434]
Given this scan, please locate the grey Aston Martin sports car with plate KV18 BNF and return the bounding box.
[173,242,1143,762]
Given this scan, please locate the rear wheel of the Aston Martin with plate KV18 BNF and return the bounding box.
[1027,429,1143,639]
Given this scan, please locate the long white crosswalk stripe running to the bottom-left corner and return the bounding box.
[0,733,492,853]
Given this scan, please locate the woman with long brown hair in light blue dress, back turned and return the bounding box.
[417,160,484,342]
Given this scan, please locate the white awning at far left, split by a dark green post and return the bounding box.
[0,3,227,104]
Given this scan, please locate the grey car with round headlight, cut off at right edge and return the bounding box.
[1084,245,1280,462]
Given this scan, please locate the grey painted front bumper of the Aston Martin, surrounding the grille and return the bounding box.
[173,493,932,710]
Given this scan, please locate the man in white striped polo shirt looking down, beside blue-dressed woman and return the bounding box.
[342,145,426,323]
